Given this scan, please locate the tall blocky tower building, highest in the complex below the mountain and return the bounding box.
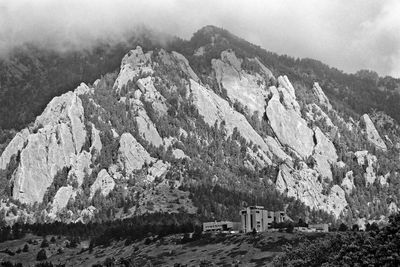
[240,206,290,233]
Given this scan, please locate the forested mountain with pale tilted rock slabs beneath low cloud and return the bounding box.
[0,26,400,230]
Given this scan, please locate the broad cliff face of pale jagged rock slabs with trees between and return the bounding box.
[0,29,390,225]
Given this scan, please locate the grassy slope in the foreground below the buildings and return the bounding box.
[0,232,328,266]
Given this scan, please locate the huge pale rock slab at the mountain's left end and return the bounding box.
[13,92,86,204]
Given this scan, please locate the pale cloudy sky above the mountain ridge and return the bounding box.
[0,0,400,78]
